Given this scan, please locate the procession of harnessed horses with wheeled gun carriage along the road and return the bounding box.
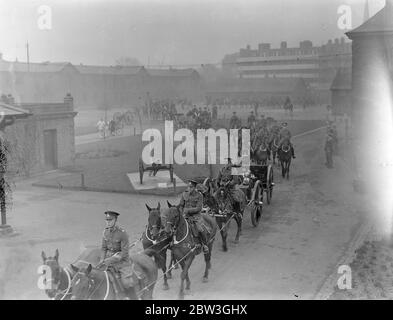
[42,112,304,300]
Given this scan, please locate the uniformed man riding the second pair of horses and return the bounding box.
[179,180,209,253]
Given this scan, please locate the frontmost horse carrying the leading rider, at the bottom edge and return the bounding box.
[71,249,158,300]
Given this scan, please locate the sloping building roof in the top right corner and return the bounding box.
[346,0,393,39]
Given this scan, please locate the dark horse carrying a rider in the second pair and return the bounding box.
[165,201,217,300]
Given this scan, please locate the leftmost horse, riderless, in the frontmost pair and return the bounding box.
[41,247,101,300]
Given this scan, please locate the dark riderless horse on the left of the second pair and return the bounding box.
[142,203,173,290]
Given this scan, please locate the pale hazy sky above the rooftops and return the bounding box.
[0,0,385,67]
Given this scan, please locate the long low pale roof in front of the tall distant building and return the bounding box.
[208,78,306,93]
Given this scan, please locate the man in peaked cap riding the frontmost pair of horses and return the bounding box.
[99,211,135,298]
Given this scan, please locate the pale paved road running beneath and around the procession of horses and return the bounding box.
[0,123,368,299]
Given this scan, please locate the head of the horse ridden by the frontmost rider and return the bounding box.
[71,264,97,300]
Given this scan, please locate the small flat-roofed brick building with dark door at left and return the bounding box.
[0,94,77,176]
